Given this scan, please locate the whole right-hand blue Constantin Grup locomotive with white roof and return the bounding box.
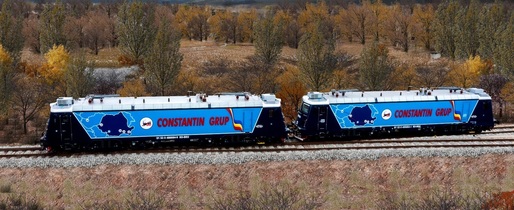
[293,87,494,140]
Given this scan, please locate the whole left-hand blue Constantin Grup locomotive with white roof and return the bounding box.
[41,93,287,150]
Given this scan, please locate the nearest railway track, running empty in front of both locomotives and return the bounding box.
[0,138,514,158]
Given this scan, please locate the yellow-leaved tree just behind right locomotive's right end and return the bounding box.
[450,56,489,88]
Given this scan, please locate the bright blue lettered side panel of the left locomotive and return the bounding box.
[74,108,262,139]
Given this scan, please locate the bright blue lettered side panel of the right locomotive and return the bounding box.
[330,100,478,129]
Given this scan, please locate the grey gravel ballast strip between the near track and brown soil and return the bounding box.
[0,147,514,168]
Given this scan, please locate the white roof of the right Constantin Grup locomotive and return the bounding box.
[303,88,491,105]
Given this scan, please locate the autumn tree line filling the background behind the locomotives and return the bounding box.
[0,0,514,143]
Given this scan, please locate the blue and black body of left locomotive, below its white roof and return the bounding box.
[41,107,287,150]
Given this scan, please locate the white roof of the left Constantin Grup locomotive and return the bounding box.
[50,93,280,112]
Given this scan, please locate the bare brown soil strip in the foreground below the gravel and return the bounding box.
[0,154,514,209]
